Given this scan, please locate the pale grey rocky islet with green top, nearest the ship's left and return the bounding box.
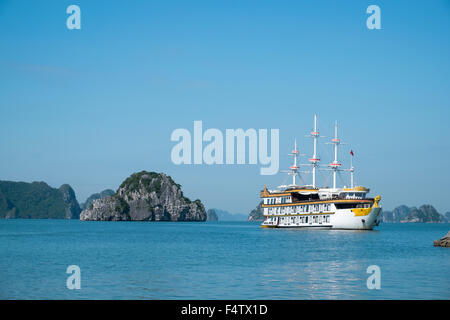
[80,171,206,221]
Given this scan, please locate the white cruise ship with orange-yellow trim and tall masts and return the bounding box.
[261,115,381,230]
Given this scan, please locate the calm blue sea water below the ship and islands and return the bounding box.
[0,220,450,299]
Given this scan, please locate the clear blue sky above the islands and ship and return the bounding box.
[0,0,450,213]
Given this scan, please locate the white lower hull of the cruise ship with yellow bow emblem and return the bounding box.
[261,207,381,230]
